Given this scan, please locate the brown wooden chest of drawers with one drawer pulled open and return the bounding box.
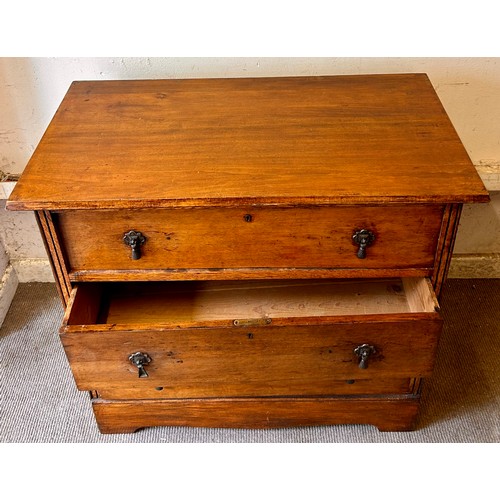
[7,74,489,432]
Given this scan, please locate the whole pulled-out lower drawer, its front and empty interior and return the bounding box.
[61,278,442,399]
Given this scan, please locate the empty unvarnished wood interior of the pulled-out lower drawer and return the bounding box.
[63,278,438,329]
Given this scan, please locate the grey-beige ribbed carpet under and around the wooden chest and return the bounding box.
[0,279,500,443]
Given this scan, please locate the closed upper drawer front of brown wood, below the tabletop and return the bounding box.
[53,205,444,273]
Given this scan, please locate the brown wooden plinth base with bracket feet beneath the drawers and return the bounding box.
[92,396,419,434]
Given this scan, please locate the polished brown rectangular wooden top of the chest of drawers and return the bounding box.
[8,74,488,210]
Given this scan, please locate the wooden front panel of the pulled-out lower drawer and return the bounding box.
[61,320,441,398]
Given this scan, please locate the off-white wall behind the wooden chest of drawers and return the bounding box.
[0,57,500,281]
